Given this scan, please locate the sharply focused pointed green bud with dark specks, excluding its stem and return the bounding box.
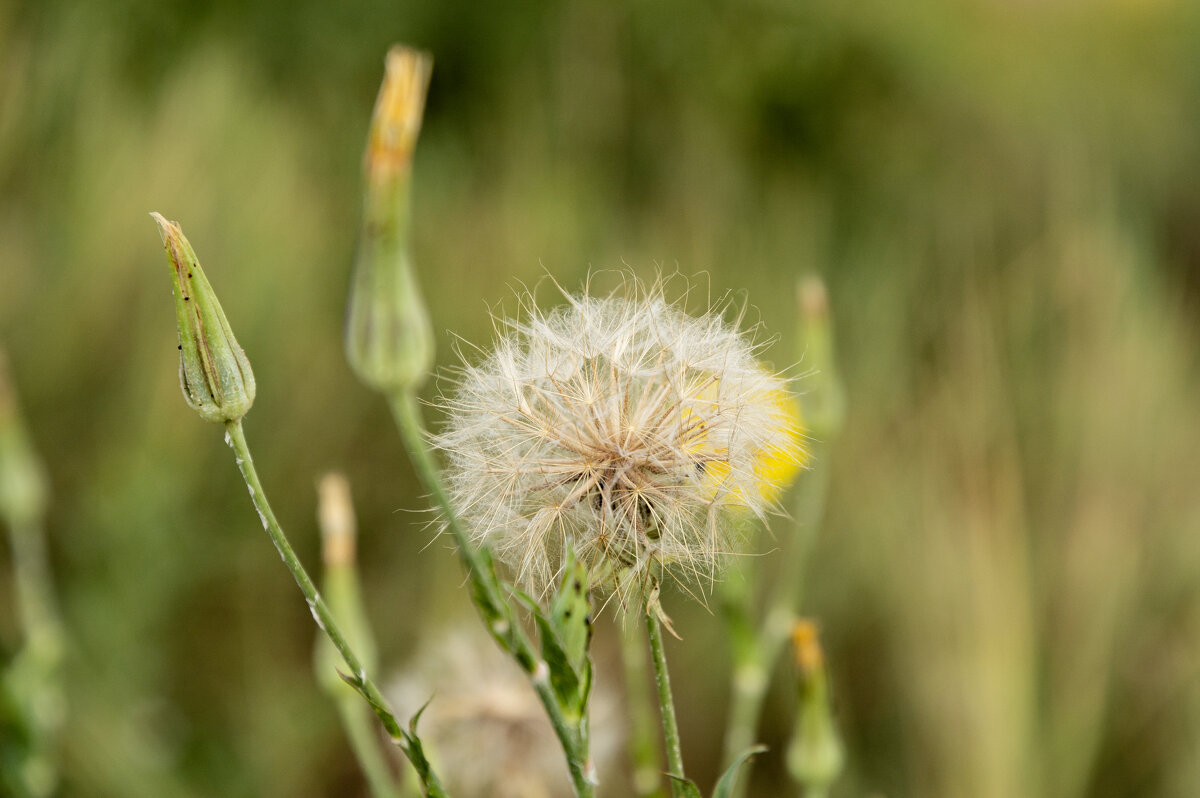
[150,214,254,422]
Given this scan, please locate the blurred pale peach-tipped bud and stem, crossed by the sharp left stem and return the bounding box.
[313,474,401,798]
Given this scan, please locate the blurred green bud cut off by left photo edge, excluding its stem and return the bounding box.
[0,349,49,527]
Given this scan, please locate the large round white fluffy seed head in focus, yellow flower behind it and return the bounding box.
[437,279,804,604]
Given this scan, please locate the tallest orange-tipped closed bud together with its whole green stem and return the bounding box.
[346,46,595,798]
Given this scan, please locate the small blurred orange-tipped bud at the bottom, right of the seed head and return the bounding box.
[787,620,846,794]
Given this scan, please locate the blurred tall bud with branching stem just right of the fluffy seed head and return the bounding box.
[721,275,845,798]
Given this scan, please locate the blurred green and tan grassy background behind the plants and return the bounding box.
[0,0,1200,798]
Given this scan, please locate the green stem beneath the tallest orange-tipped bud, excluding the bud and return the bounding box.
[391,391,595,798]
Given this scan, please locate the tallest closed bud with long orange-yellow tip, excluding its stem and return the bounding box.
[346,47,433,395]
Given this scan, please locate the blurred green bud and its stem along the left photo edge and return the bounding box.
[0,349,66,798]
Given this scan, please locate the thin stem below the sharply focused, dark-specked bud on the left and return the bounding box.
[226,420,445,798]
